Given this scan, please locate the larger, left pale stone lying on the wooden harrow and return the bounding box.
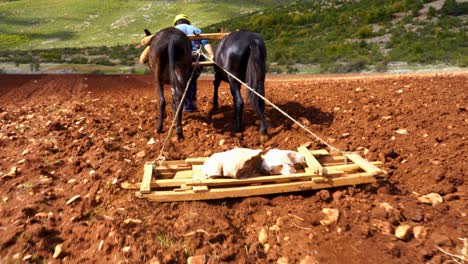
[202,148,262,179]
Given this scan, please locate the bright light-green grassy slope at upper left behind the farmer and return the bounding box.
[0,0,275,50]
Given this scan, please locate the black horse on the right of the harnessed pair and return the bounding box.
[213,31,267,134]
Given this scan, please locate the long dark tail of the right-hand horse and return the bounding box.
[246,40,266,113]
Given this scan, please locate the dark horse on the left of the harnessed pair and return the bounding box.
[145,27,192,141]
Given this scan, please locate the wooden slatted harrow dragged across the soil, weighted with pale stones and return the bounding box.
[121,147,386,202]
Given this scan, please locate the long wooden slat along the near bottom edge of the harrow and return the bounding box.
[136,173,376,202]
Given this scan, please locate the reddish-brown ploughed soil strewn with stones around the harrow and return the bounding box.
[0,72,468,263]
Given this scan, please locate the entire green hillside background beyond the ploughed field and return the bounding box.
[0,0,468,73]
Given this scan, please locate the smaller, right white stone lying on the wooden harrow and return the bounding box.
[262,149,305,175]
